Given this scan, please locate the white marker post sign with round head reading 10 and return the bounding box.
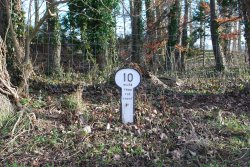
[115,68,141,124]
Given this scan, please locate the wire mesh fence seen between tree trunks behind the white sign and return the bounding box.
[31,31,248,77]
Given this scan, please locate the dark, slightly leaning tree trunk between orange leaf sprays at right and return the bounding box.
[210,0,225,71]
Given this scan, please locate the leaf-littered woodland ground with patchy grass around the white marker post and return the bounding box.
[0,68,250,167]
